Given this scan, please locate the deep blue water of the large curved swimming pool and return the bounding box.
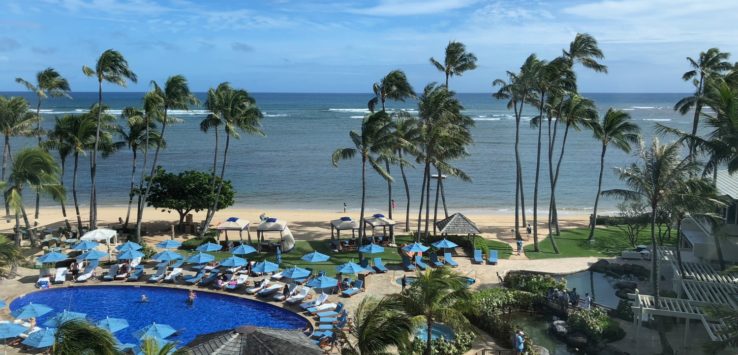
[10,286,307,346]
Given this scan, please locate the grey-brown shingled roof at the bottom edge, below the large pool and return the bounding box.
[187,326,323,355]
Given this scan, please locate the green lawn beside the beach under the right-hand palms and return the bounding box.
[525,226,676,259]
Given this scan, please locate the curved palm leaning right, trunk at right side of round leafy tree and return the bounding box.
[200,83,264,237]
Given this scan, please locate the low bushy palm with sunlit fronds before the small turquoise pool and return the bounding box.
[389,267,471,355]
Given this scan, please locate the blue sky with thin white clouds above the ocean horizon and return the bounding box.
[0,0,738,92]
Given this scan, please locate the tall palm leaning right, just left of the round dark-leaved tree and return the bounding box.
[136,75,198,240]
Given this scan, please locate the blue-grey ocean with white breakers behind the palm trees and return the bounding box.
[0,92,691,215]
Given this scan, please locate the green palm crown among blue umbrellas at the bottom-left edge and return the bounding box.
[51,319,119,355]
